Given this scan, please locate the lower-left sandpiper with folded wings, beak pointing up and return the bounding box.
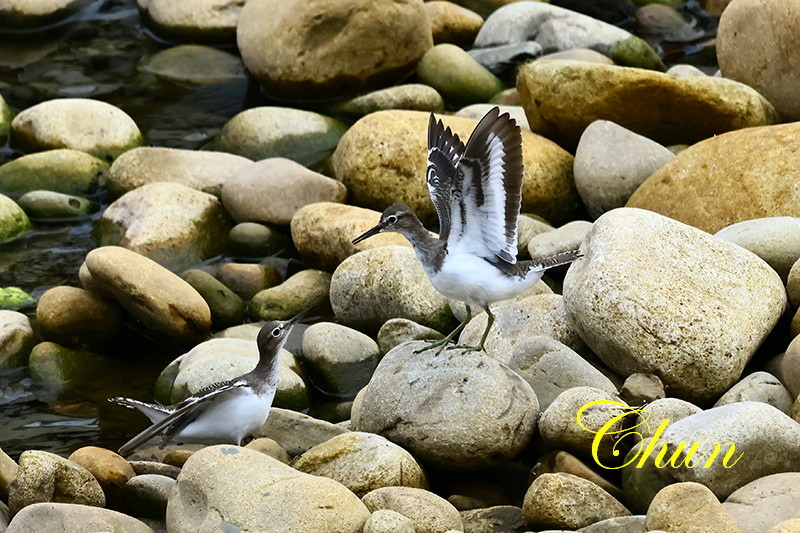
[108,310,309,456]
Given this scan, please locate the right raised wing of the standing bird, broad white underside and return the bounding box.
[447,107,522,272]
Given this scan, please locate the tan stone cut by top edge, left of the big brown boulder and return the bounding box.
[137,0,242,43]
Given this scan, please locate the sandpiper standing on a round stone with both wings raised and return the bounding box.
[353,107,581,351]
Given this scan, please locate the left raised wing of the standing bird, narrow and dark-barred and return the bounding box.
[427,113,464,241]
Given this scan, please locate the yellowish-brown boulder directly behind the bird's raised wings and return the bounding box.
[331,111,579,224]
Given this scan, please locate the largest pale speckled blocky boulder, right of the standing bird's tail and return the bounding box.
[564,208,786,401]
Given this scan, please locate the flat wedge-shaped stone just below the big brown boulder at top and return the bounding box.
[329,84,444,120]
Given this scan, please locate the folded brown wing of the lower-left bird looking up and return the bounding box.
[111,378,247,456]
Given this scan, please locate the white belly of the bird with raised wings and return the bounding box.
[428,254,542,307]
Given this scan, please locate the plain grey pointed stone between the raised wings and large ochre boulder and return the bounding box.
[575,120,675,218]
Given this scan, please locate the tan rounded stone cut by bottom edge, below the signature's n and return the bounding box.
[645,482,739,533]
